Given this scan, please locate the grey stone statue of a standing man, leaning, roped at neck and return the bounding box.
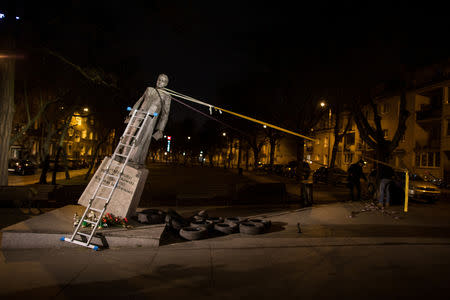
[123,74,171,169]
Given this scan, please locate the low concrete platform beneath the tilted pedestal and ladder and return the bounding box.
[1,205,165,249]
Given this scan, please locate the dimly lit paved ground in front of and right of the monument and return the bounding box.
[0,203,450,299]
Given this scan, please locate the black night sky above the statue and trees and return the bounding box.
[0,1,449,122]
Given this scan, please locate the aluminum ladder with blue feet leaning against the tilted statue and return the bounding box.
[60,110,158,251]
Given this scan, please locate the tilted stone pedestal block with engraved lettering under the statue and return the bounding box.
[78,157,148,218]
